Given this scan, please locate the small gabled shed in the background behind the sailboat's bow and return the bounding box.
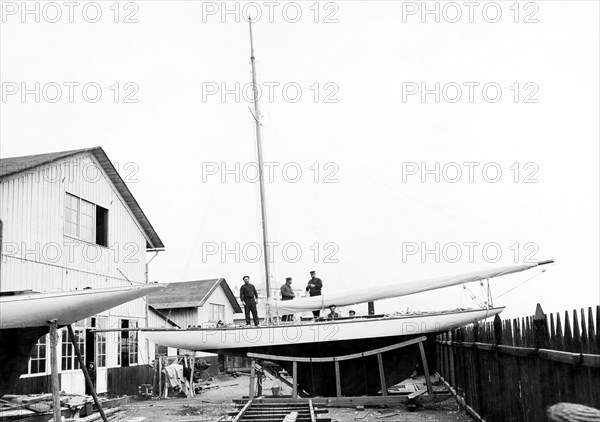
[148,278,242,336]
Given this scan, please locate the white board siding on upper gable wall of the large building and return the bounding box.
[0,153,146,291]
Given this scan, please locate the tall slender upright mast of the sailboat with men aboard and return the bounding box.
[248,17,271,299]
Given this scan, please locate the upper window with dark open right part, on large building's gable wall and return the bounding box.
[65,193,108,246]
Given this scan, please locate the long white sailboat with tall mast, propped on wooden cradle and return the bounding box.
[142,20,553,396]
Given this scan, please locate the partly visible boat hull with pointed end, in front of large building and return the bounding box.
[0,284,165,397]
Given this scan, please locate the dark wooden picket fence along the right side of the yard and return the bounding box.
[436,304,600,422]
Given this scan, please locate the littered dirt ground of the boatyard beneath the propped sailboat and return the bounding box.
[119,375,472,422]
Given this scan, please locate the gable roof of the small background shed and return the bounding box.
[148,278,242,313]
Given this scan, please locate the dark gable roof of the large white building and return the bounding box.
[0,147,165,250]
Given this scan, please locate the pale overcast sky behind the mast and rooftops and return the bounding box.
[0,1,600,316]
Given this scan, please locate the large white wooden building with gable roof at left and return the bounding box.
[0,147,164,393]
